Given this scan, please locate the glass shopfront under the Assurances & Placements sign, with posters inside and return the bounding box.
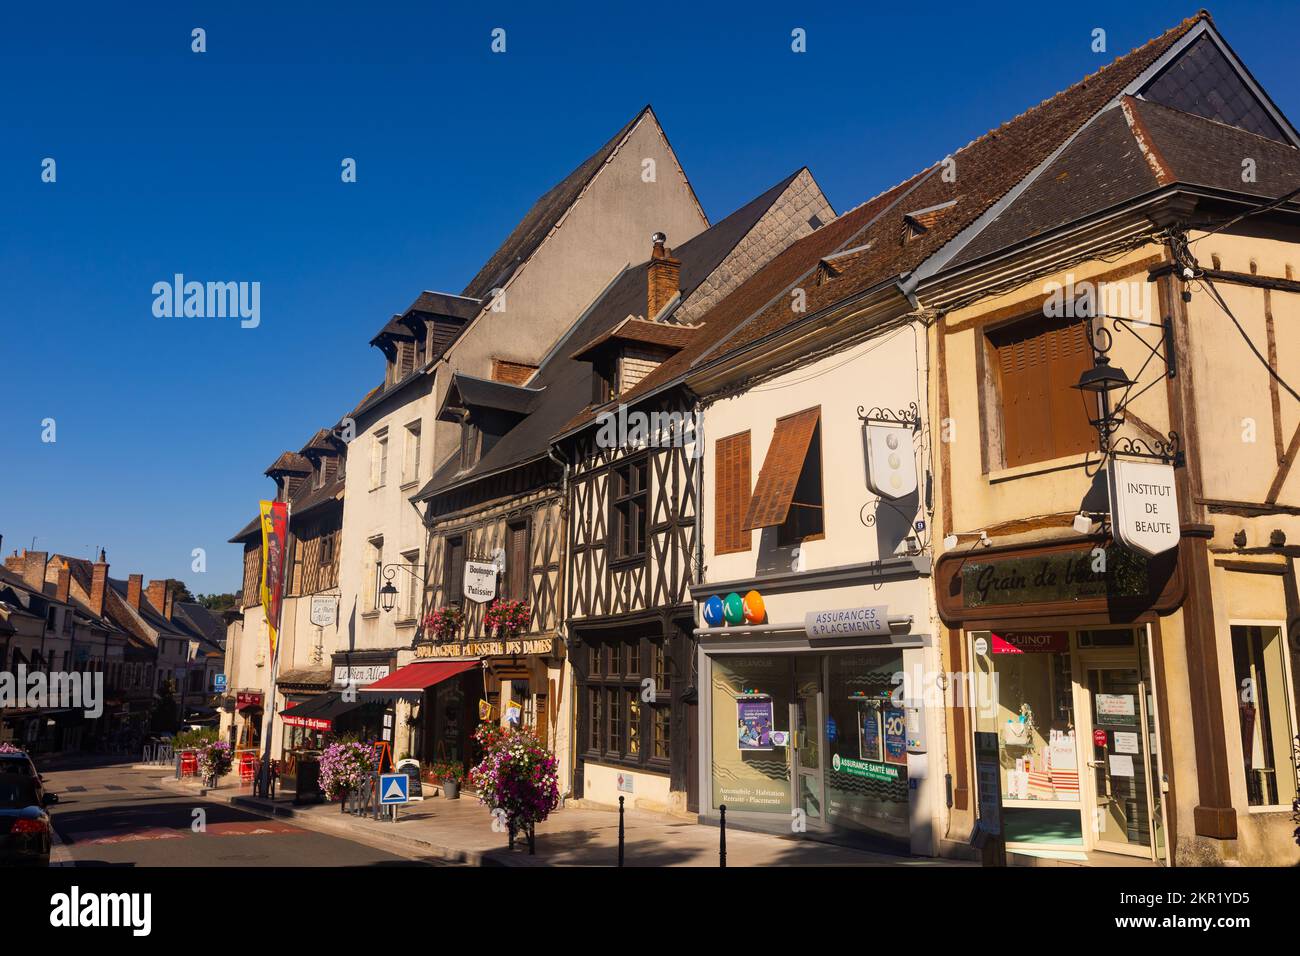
[710,648,909,840]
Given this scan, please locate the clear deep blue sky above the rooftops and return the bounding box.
[0,0,1300,593]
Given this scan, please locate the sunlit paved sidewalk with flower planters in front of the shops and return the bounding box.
[161,777,969,866]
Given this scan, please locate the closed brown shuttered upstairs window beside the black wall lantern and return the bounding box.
[985,317,1097,468]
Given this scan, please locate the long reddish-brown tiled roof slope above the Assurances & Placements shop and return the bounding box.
[564,12,1209,433]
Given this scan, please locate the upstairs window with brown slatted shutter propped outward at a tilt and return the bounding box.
[741,407,826,546]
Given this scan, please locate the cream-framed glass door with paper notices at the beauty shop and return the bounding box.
[1082,663,1156,860]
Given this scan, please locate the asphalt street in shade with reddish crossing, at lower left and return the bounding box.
[38,758,441,866]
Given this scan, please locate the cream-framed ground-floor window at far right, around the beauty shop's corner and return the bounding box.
[1232,624,1296,806]
